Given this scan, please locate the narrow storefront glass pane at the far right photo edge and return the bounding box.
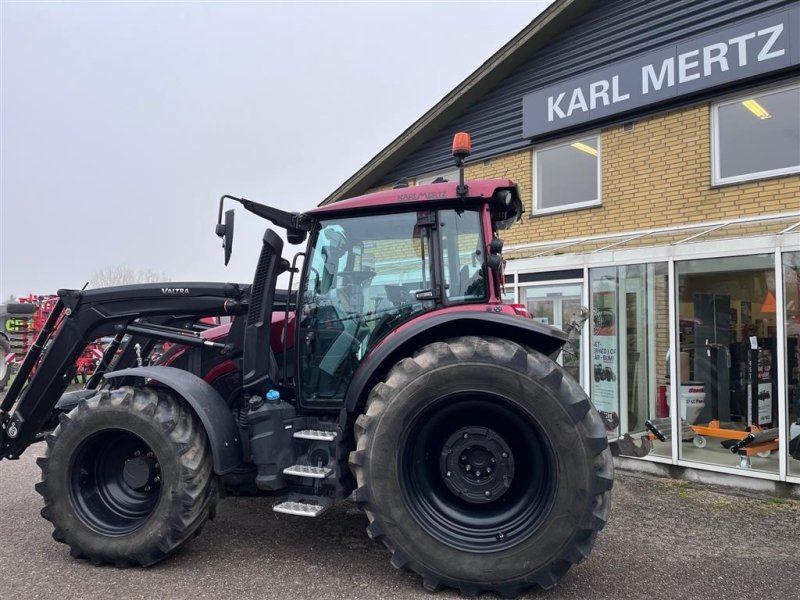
[783,252,800,476]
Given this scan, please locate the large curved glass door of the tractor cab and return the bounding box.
[298,212,434,406]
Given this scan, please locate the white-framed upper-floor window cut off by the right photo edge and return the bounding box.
[713,86,800,184]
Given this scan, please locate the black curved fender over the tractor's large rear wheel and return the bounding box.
[345,309,567,412]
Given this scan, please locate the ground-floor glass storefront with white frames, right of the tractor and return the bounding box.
[509,237,800,482]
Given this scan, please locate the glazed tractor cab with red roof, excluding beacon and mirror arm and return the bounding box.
[298,183,513,405]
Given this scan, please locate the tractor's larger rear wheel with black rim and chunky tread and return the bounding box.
[350,337,613,598]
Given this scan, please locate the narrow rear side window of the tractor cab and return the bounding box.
[439,210,488,303]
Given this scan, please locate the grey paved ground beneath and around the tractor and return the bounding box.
[0,445,800,600]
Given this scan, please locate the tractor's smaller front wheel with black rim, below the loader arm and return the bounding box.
[36,387,217,567]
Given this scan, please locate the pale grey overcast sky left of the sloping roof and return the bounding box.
[0,0,550,302]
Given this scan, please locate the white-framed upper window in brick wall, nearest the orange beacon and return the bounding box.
[533,136,600,214]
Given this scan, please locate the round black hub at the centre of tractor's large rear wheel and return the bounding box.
[439,427,514,504]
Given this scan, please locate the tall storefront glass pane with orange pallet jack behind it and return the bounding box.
[676,254,779,473]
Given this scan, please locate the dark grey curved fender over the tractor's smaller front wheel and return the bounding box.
[103,366,242,475]
